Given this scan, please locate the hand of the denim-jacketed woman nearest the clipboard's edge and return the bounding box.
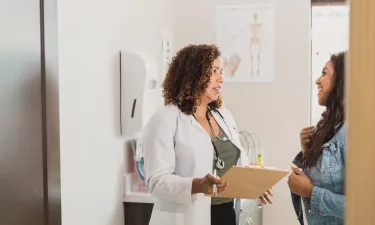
[288,166,314,198]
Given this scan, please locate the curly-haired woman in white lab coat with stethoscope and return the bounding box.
[143,45,272,225]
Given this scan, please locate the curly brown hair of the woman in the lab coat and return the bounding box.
[163,45,222,115]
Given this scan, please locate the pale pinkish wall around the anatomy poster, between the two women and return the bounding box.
[174,0,311,225]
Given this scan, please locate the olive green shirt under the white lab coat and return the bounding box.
[211,128,241,205]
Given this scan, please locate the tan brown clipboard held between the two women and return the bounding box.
[208,166,290,199]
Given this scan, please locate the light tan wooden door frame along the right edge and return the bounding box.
[345,0,375,225]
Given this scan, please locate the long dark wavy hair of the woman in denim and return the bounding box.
[300,52,346,168]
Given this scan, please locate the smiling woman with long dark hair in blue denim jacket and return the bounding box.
[288,52,346,225]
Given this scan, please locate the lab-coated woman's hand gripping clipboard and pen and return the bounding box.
[191,173,227,194]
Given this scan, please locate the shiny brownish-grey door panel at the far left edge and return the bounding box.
[0,0,44,225]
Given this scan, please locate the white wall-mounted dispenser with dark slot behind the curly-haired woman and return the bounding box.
[120,51,163,137]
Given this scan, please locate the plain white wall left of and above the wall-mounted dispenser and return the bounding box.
[58,0,172,225]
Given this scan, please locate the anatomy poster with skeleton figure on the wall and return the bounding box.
[216,4,275,83]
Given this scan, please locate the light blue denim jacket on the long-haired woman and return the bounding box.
[291,124,346,225]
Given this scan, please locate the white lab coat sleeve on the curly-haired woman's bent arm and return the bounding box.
[143,112,193,203]
